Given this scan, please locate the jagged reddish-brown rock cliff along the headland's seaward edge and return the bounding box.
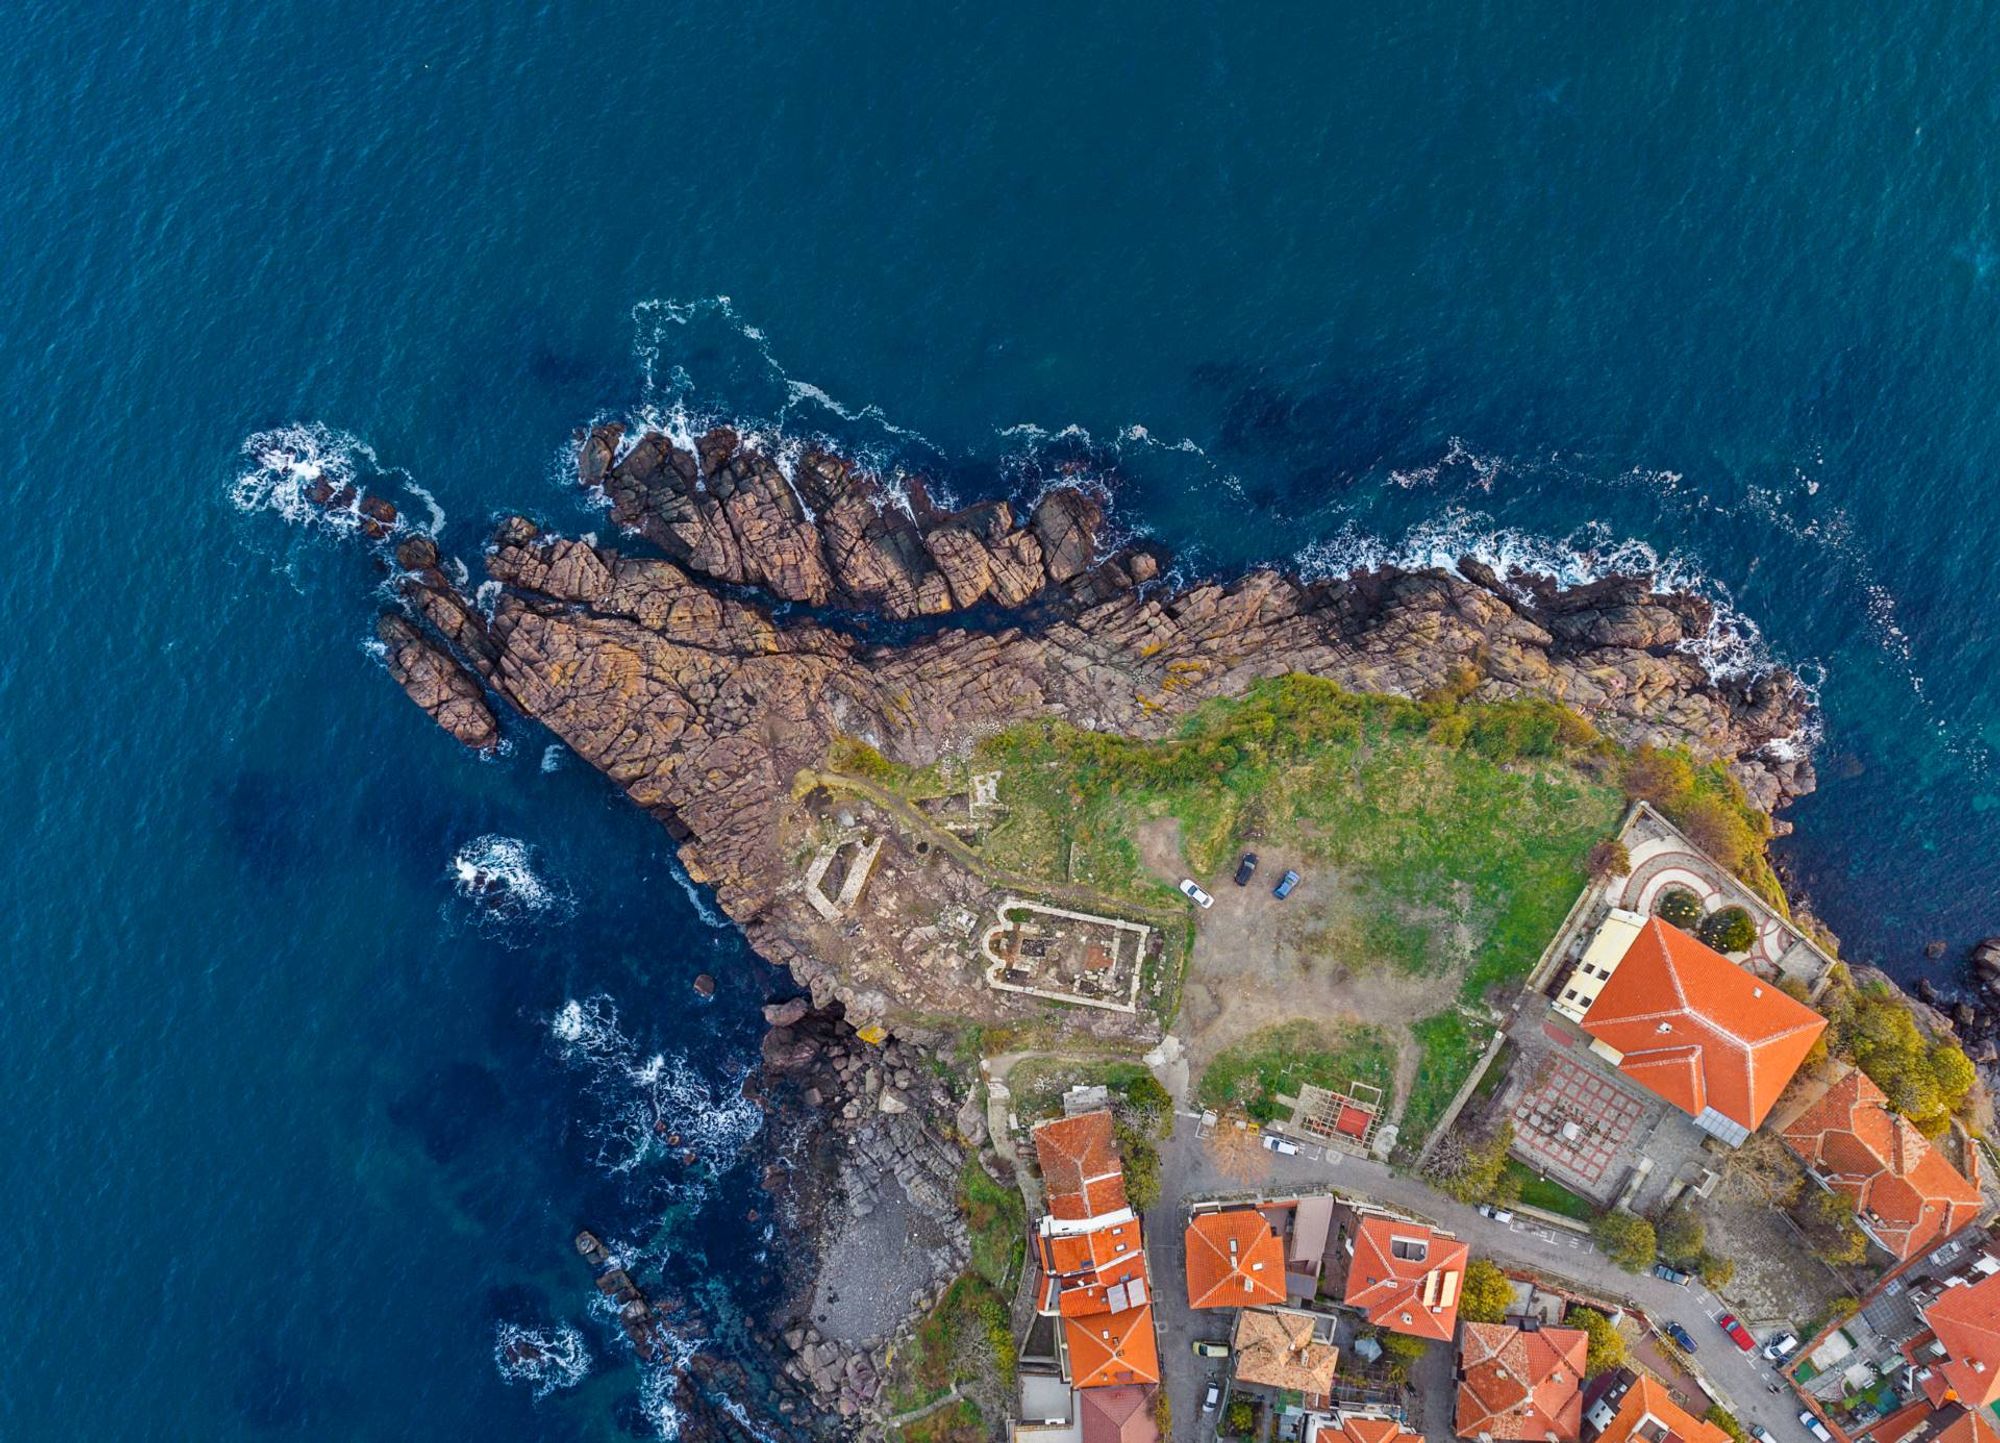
[324,426,1812,1015]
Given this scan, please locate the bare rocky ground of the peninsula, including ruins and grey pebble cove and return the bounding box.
[318,426,1814,1417]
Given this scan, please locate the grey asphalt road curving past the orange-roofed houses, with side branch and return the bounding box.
[1146,1113,1810,1443]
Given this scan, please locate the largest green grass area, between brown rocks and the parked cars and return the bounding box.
[974,676,1624,999]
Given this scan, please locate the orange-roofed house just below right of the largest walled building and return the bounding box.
[1784,1067,1986,1261]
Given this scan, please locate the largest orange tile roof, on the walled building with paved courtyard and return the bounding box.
[1584,917,1826,1131]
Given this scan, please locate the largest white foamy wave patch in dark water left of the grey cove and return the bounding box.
[548,993,764,1201]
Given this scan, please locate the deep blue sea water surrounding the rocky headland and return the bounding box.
[11,0,2000,1441]
